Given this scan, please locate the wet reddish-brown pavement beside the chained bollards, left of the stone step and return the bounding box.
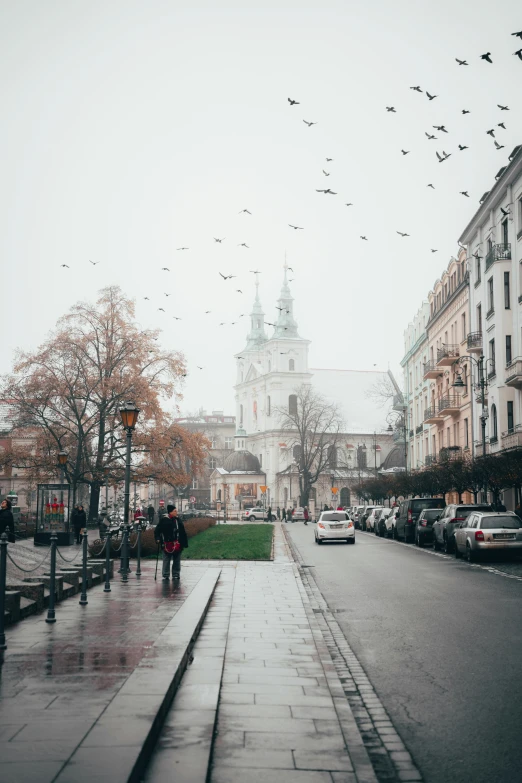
[0,562,215,783]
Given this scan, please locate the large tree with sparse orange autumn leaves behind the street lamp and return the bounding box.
[2,286,207,519]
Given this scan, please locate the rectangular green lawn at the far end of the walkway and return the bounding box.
[182,524,274,560]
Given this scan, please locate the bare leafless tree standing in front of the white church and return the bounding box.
[276,384,344,506]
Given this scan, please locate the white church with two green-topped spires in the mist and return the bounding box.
[211,263,404,512]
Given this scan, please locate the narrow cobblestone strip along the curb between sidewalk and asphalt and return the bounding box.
[284,531,422,783]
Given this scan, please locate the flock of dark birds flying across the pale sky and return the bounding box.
[60,30,522,370]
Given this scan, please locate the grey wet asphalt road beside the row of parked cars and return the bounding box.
[287,523,522,783]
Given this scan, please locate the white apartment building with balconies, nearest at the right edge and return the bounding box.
[460,145,522,502]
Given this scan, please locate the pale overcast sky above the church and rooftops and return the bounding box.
[0,0,522,413]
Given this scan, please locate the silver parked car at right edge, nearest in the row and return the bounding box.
[455,511,522,563]
